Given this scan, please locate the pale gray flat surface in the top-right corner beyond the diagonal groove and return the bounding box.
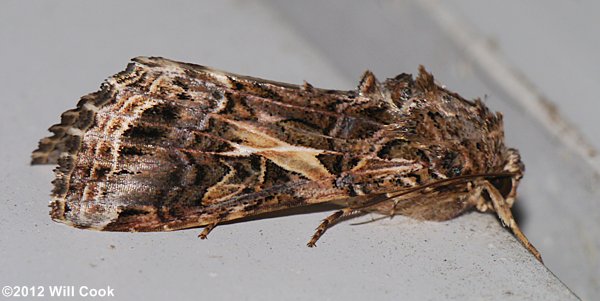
[446,0,600,154]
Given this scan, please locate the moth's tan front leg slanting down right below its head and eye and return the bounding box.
[484,181,543,263]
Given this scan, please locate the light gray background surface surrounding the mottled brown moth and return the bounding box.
[0,0,600,300]
